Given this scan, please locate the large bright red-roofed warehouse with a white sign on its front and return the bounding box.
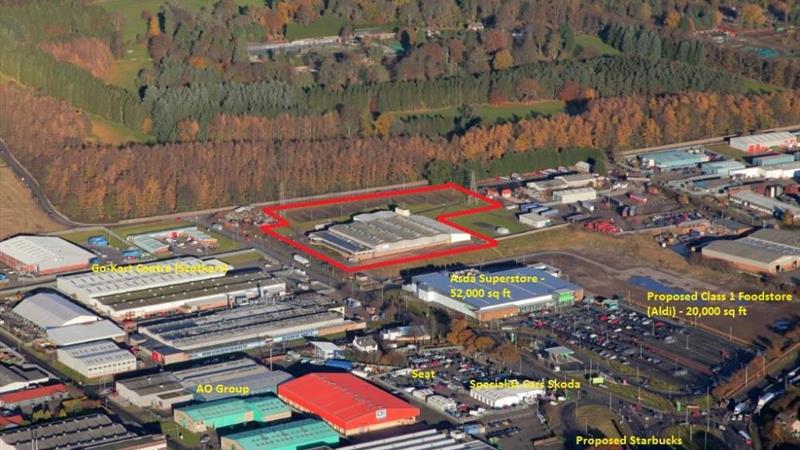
[278,373,419,436]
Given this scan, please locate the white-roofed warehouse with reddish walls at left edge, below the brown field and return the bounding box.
[0,236,94,275]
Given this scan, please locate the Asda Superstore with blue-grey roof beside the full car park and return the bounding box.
[403,267,583,321]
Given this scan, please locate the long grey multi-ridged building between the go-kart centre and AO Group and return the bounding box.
[139,294,365,360]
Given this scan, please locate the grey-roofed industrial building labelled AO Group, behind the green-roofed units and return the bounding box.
[116,358,292,410]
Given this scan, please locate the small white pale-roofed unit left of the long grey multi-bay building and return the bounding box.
[56,341,136,378]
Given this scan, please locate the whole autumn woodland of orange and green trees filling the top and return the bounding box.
[0,0,800,220]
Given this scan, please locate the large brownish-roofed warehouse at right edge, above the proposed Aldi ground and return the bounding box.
[702,228,800,273]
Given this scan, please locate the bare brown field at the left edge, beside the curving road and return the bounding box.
[0,162,64,239]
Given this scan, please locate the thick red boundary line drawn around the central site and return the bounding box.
[261,183,503,273]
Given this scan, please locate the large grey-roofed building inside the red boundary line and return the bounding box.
[309,209,471,261]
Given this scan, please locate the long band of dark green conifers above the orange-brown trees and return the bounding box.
[144,57,742,142]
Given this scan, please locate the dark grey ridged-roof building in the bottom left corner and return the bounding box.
[0,414,137,450]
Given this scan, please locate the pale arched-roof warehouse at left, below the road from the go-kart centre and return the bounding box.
[12,292,99,330]
